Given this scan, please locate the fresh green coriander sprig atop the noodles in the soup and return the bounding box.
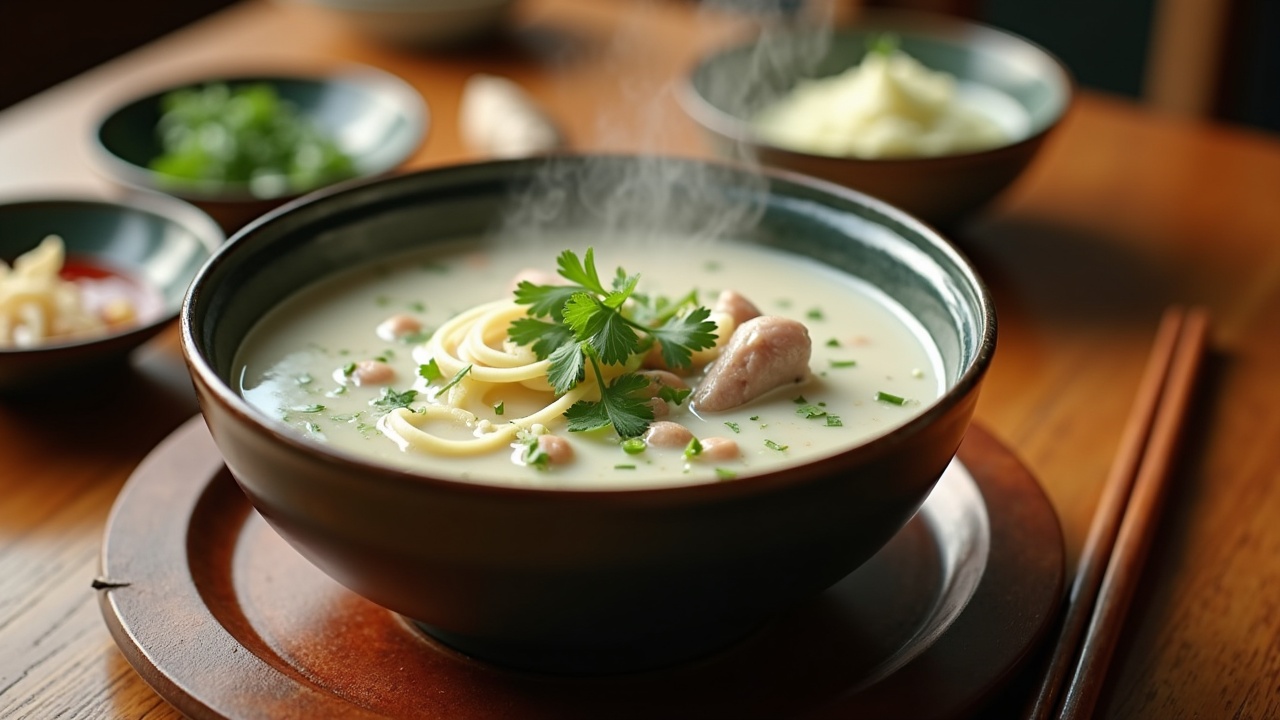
[507,247,716,437]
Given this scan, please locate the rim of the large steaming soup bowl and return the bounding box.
[179,152,997,503]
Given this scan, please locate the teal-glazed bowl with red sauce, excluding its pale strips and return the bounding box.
[0,196,224,392]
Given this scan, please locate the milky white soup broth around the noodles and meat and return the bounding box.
[234,238,943,489]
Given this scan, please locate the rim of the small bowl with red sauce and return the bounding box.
[0,192,227,357]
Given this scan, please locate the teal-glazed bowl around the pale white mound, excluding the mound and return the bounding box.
[678,12,1073,224]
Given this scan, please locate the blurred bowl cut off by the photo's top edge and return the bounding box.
[294,0,515,49]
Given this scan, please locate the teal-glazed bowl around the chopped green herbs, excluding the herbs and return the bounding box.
[92,65,428,233]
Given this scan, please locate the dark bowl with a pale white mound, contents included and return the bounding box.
[680,12,1073,225]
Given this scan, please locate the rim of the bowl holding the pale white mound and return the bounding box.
[675,8,1078,168]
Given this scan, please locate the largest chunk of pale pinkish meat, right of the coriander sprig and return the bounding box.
[690,315,813,413]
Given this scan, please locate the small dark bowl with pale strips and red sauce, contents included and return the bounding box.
[0,195,225,393]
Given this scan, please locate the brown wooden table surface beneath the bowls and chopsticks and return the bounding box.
[0,0,1280,719]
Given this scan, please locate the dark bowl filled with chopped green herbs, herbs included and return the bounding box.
[95,67,428,233]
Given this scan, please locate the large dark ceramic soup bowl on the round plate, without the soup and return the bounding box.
[182,156,996,673]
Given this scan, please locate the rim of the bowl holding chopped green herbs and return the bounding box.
[88,60,431,204]
